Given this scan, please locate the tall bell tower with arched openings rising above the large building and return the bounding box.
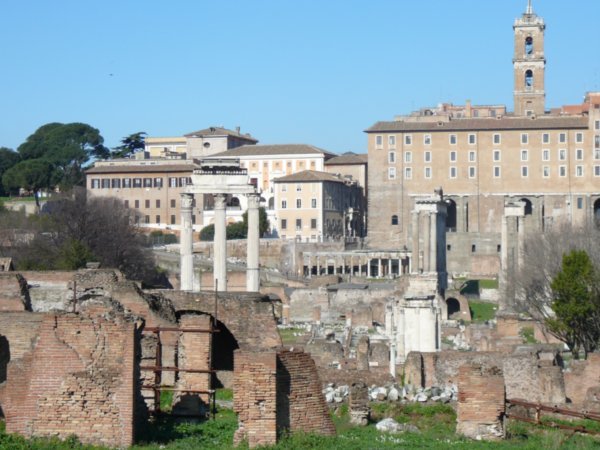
[513,0,546,116]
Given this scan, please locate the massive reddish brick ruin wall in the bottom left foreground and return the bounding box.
[3,308,139,447]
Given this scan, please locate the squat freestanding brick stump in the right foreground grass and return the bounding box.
[456,364,506,440]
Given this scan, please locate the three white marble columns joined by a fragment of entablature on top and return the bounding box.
[180,158,260,292]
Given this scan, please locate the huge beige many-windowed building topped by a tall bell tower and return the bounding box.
[366,2,600,274]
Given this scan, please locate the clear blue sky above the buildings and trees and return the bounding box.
[0,0,600,153]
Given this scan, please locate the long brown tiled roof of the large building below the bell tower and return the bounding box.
[365,117,589,133]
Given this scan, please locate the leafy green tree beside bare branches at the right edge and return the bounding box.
[546,250,600,358]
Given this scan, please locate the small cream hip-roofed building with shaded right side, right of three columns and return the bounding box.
[274,170,364,242]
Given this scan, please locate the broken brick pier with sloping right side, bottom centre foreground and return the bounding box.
[234,350,335,447]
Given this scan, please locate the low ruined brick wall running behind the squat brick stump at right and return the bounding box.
[404,347,566,404]
